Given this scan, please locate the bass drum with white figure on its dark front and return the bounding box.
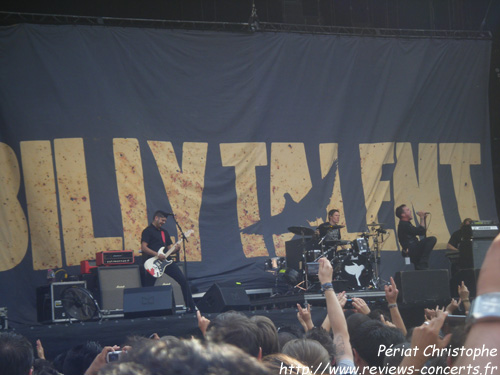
[337,254,373,290]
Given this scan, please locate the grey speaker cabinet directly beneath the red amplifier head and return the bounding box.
[97,265,141,311]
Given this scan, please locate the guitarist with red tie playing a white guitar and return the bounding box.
[141,211,196,313]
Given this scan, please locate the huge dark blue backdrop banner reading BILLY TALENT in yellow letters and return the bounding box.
[0,24,497,322]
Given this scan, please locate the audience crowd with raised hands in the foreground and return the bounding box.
[0,236,500,375]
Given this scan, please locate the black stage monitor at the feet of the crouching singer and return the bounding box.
[394,270,451,304]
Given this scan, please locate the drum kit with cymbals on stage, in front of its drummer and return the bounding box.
[266,223,386,291]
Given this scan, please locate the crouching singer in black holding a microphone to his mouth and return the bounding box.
[396,204,437,270]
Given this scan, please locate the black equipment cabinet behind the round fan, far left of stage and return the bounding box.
[36,281,87,323]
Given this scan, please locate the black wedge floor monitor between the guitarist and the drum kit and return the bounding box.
[197,283,250,313]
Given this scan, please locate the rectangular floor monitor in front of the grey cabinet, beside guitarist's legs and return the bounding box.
[123,285,175,319]
